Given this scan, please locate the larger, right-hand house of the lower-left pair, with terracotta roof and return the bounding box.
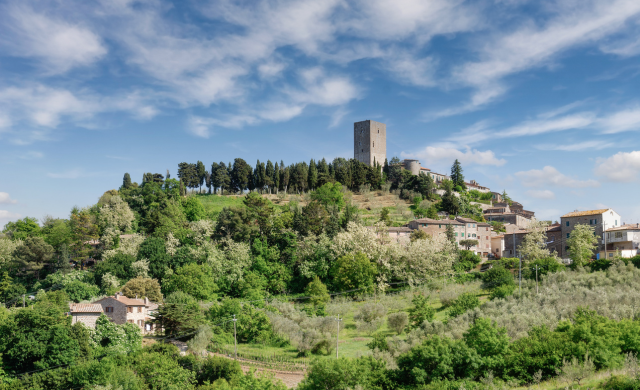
[94,293,158,333]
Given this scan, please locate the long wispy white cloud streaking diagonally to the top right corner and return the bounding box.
[451,0,640,114]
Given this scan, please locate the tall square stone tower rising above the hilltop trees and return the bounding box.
[353,120,387,166]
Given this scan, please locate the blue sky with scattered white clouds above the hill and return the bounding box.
[0,0,640,226]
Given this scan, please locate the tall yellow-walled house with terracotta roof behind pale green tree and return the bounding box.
[560,209,622,254]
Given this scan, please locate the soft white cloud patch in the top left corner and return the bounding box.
[3,4,107,73]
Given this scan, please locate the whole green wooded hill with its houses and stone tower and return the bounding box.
[0,121,640,390]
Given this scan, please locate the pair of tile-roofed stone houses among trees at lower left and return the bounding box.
[69,293,158,334]
